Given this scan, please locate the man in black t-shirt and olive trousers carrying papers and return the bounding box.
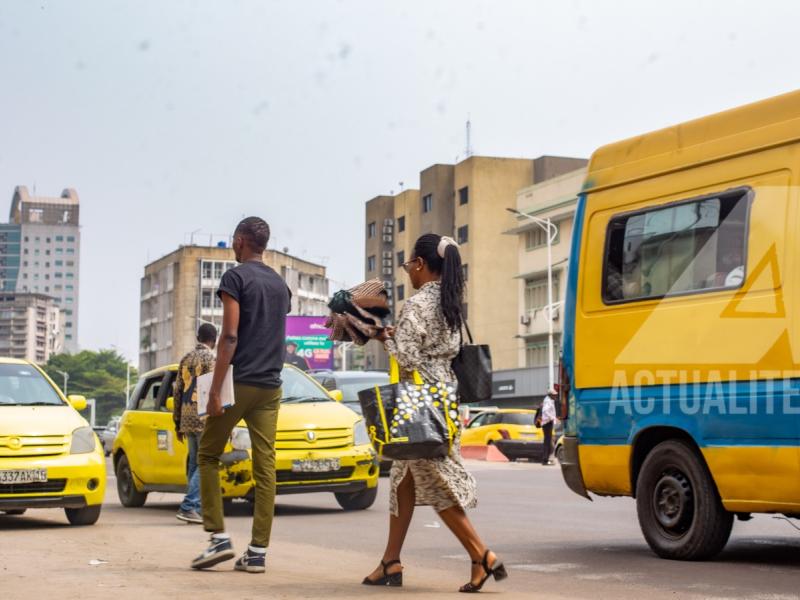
[192,217,291,573]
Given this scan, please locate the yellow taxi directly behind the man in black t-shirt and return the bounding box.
[112,365,378,510]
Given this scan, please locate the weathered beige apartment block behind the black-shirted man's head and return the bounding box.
[139,246,329,371]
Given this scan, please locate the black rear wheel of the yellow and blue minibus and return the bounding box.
[636,440,733,560]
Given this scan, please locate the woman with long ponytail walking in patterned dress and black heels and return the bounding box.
[363,233,508,592]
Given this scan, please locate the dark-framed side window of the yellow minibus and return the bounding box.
[603,188,752,304]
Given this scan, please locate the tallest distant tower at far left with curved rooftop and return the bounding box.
[0,186,80,352]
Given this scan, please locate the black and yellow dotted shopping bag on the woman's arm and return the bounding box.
[358,358,458,460]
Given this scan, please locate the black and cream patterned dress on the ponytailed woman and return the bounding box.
[385,281,477,516]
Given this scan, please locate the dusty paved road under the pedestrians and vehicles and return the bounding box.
[0,462,800,600]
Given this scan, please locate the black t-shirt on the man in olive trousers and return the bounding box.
[217,261,292,388]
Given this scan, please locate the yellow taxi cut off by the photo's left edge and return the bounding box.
[0,358,106,525]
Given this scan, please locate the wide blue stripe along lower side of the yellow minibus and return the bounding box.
[570,379,800,446]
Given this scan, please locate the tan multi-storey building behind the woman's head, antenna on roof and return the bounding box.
[365,156,586,369]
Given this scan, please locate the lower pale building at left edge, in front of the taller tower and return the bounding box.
[0,291,65,364]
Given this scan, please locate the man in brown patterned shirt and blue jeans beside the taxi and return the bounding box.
[172,323,217,523]
